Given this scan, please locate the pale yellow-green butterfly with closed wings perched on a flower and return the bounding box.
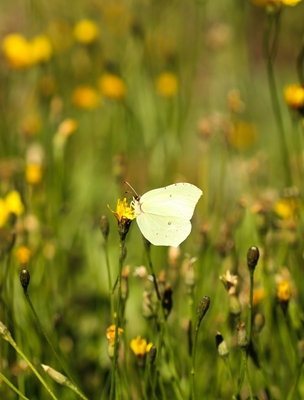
[126,182,203,247]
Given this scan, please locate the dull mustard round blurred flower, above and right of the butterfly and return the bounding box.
[228,121,258,150]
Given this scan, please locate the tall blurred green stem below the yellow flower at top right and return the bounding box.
[263,7,292,186]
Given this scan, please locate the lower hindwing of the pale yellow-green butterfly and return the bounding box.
[136,214,191,247]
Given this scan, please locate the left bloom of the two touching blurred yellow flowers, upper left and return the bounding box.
[2,33,32,68]
